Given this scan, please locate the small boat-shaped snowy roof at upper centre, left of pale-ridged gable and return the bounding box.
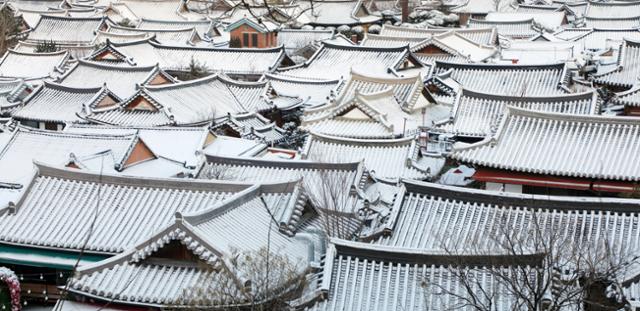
[265,74,344,107]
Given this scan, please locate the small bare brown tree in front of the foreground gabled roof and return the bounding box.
[170,248,307,311]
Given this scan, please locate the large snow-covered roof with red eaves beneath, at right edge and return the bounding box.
[451,107,640,181]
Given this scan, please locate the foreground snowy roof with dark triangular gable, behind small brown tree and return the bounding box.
[70,184,320,307]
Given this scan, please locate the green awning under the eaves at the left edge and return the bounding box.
[0,244,110,271]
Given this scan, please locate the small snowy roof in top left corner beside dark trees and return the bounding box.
[27,15,105,45]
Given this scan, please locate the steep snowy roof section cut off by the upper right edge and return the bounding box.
[594,39,640,88]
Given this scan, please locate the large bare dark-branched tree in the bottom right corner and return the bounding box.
[423,210,639,311]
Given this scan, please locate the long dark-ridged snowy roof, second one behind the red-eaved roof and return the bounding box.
[433,62,569,96]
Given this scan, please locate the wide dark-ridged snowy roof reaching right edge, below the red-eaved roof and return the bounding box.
[362,181,640,254]
